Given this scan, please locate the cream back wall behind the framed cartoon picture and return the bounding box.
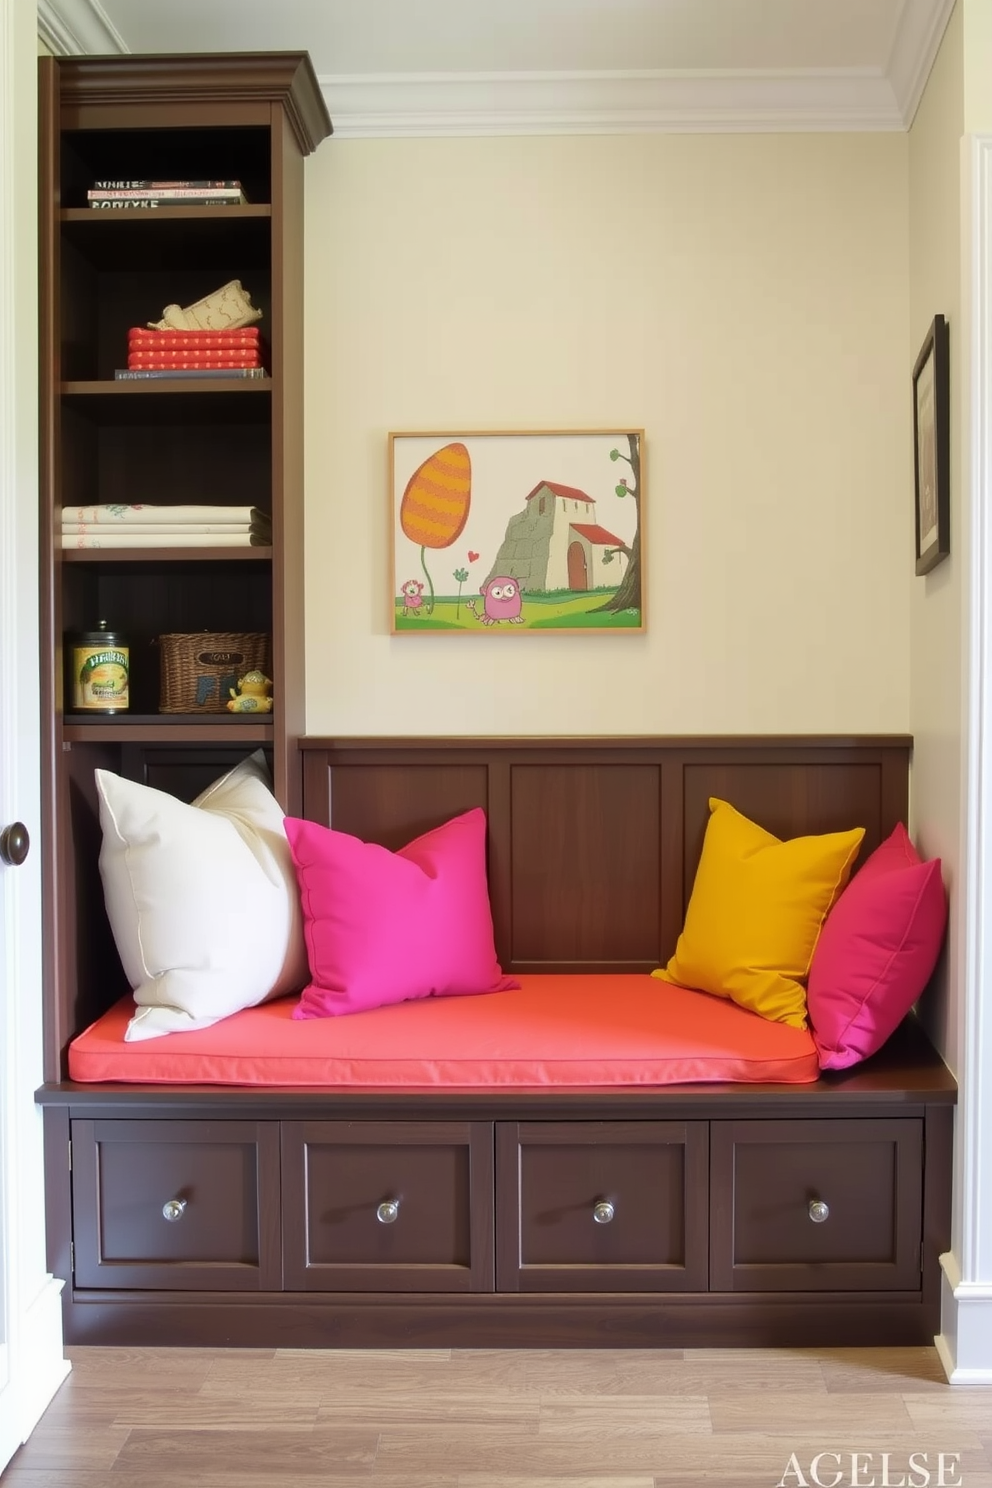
[306,134,910,734]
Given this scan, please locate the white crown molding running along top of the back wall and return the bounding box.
[320,68,904,138]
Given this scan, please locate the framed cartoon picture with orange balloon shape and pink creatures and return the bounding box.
[390,429,644,635]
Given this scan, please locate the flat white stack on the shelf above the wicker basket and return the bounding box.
[61,503,272,548]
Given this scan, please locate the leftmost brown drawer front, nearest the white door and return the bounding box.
[71,1120,281,1292]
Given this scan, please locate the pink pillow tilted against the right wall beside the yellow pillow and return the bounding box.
[806,823,947,1070]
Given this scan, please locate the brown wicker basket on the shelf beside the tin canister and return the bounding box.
[159,631,272,713]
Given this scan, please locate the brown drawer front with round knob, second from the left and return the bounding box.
[283,1122,492,1292]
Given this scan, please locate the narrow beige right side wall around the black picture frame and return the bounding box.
[906,4,968,1070]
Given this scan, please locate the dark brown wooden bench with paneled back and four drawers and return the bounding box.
[39,737,955,1347]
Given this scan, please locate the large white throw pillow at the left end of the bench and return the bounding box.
[95,750,309,1042]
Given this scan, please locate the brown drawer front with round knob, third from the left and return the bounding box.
[497,1122,708,1292]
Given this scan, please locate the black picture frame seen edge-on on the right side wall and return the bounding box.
[913,315,950,574]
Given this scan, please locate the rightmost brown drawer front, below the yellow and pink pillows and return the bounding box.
[709,1119,924,1292]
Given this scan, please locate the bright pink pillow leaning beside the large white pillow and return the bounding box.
[286,806,521,1018]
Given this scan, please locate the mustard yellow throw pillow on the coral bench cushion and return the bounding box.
[651,796,864,1028]
